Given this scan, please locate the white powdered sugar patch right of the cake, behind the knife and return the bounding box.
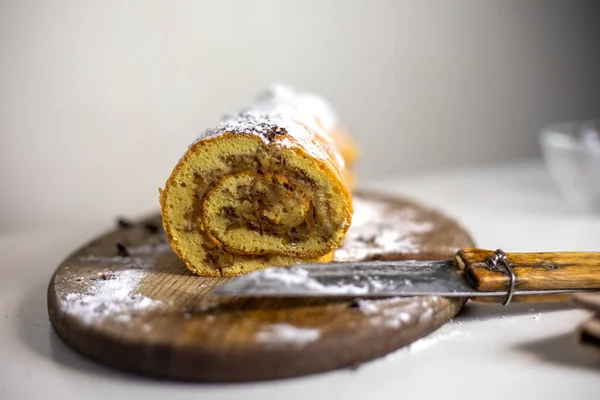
[334,197,435,261]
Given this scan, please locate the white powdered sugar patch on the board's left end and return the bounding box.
[59,244,169,325]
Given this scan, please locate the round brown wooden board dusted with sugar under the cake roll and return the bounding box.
[48,193,473,382]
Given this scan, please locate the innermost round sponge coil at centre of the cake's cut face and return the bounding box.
[202,171,316,254]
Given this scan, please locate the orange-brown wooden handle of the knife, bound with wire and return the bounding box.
[456,249,600,302]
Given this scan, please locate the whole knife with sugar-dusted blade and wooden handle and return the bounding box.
[213,248,600,305]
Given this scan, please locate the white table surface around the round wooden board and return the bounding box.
[0,162,600,400]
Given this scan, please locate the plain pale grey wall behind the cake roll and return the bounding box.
[0,0,600,231]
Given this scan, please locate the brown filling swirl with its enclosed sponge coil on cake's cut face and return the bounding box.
[184,148,336,265]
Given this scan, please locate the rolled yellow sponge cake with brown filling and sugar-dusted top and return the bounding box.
[160,86,357,276]
